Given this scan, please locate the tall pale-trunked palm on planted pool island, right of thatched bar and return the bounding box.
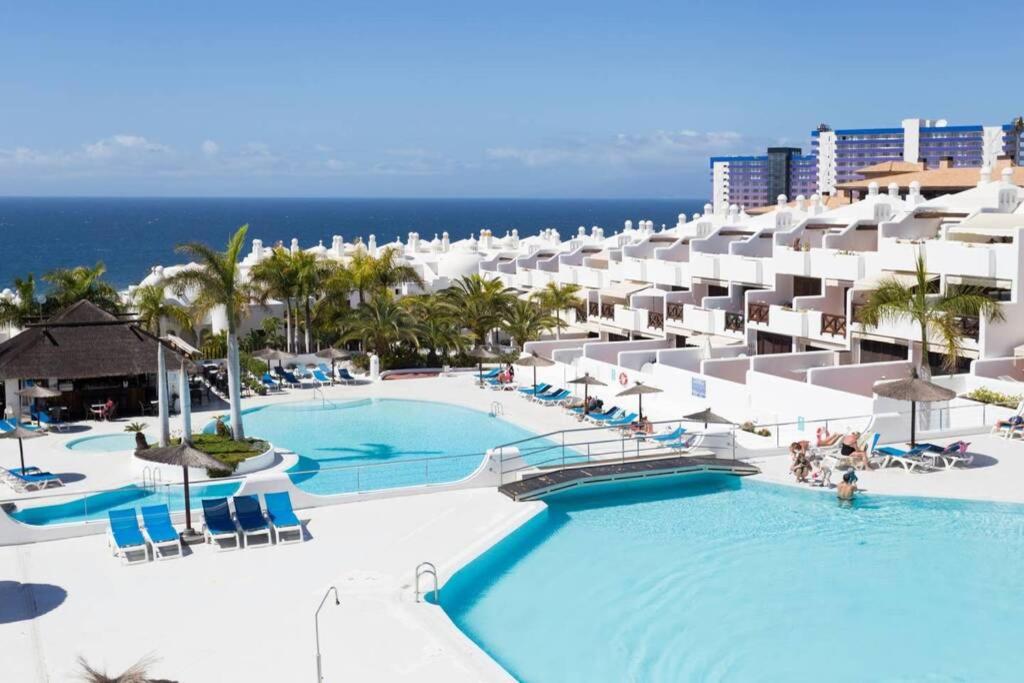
[167,224,252,439]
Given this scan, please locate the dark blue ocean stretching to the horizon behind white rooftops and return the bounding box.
[0,198,705,289]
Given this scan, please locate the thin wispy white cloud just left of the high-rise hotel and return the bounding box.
[485,130,744,167]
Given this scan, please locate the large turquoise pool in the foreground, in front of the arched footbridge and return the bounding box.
[441,475,1024,683]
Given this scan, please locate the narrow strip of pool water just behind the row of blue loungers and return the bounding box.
[10,481,240,525]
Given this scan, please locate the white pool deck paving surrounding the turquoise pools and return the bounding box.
[0,371,1024,683]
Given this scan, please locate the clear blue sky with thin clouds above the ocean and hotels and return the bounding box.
[0,0,1022,198]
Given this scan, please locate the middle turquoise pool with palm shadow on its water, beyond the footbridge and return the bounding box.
[236,398,565,495]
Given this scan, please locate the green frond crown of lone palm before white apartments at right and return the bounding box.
[860,253,1006,378]
